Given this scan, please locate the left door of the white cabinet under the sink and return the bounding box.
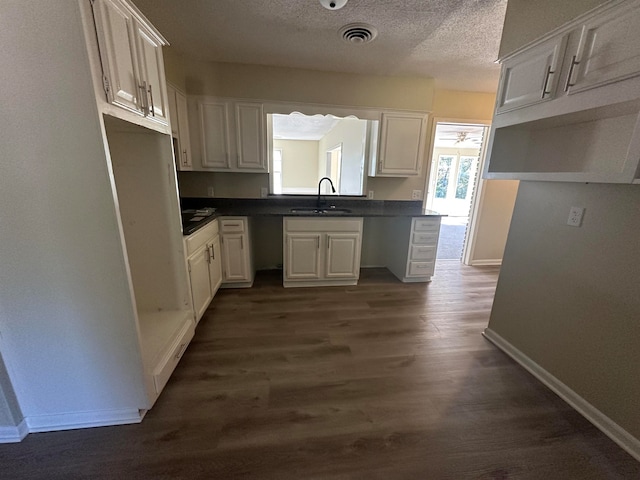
[285,233,321,280]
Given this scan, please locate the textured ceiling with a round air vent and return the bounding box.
[134,0,507,92]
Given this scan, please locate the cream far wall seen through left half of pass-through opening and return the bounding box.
[273,140,319,190]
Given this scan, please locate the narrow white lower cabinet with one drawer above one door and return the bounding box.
[220,217,255,288]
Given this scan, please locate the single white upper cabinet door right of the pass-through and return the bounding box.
[377,113,427,177]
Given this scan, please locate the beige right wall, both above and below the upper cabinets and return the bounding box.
[489,0,640,439]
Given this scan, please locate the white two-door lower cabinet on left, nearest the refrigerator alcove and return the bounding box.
[185,220,222,323]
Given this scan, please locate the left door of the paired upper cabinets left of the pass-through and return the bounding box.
[198,101,230,170]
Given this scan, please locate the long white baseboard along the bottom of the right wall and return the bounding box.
[483,328,640,461]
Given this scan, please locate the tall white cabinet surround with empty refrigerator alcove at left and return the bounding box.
[0,0,194,440]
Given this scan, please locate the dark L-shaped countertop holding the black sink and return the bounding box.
[180,196,445,235]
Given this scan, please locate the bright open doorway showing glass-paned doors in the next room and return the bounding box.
[426,121,489,260]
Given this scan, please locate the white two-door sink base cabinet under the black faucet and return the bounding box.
[283,217,362,287]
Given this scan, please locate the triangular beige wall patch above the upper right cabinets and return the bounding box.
[498,0,605,58]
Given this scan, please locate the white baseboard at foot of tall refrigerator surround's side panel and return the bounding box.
[25,409,143,433]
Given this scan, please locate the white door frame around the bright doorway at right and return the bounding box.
[424,117,491,265]
